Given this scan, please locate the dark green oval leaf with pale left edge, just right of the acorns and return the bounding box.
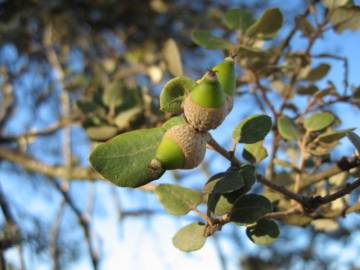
[232,114,272,143]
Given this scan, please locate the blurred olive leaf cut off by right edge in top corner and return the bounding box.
[329,6,360,32]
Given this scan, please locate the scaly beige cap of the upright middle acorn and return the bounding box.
[184,95,227,132]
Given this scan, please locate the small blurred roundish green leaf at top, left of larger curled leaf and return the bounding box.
[225,8,254,31]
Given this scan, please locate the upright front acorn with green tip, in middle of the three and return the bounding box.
[183,70,227,132]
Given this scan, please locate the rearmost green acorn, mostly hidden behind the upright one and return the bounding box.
[212,57,236,114]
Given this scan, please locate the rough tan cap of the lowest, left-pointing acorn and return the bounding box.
[164,124,209,169]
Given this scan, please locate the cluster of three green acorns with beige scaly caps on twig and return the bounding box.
[150,57,236,173]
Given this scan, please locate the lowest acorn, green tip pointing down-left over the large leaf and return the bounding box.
[150,123,209,170]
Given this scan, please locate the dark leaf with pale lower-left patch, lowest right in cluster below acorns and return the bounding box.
[246,219,280,245]
